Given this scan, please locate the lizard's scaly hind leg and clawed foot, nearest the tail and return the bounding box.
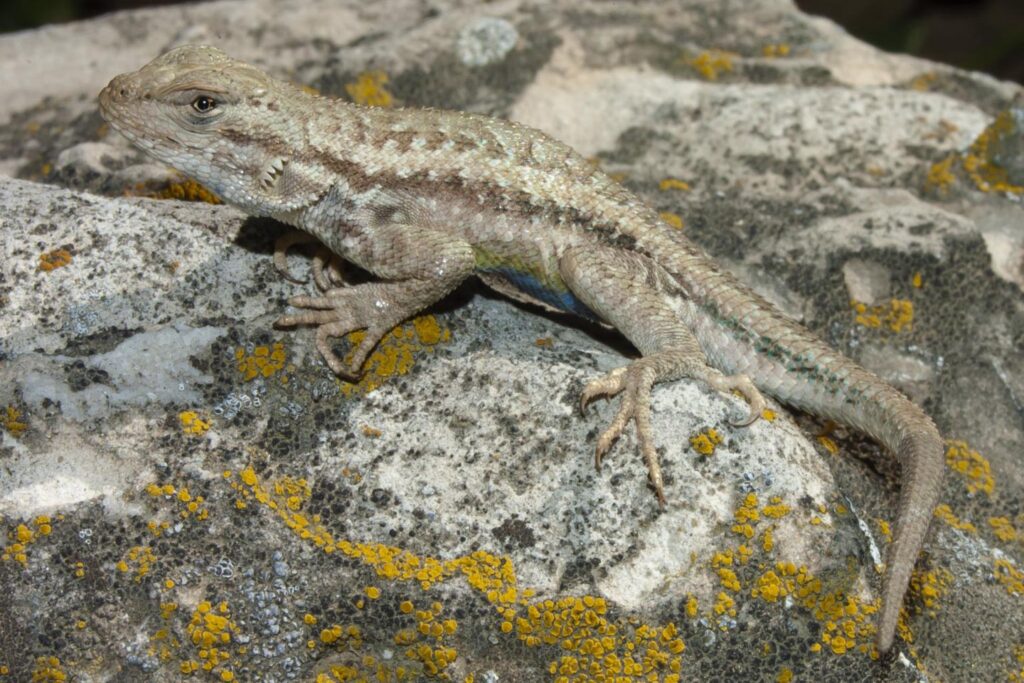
[558,247,765,506]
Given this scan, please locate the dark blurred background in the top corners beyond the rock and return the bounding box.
[0,0,1024,83]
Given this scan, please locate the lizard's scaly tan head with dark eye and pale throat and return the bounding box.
[99,45,325,215]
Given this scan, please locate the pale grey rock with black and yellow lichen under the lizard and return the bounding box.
[0,0,1024,681]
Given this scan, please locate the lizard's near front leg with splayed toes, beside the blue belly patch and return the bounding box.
[275,223,474,379]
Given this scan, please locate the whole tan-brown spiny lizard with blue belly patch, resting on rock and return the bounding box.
[99,45,944,652]
